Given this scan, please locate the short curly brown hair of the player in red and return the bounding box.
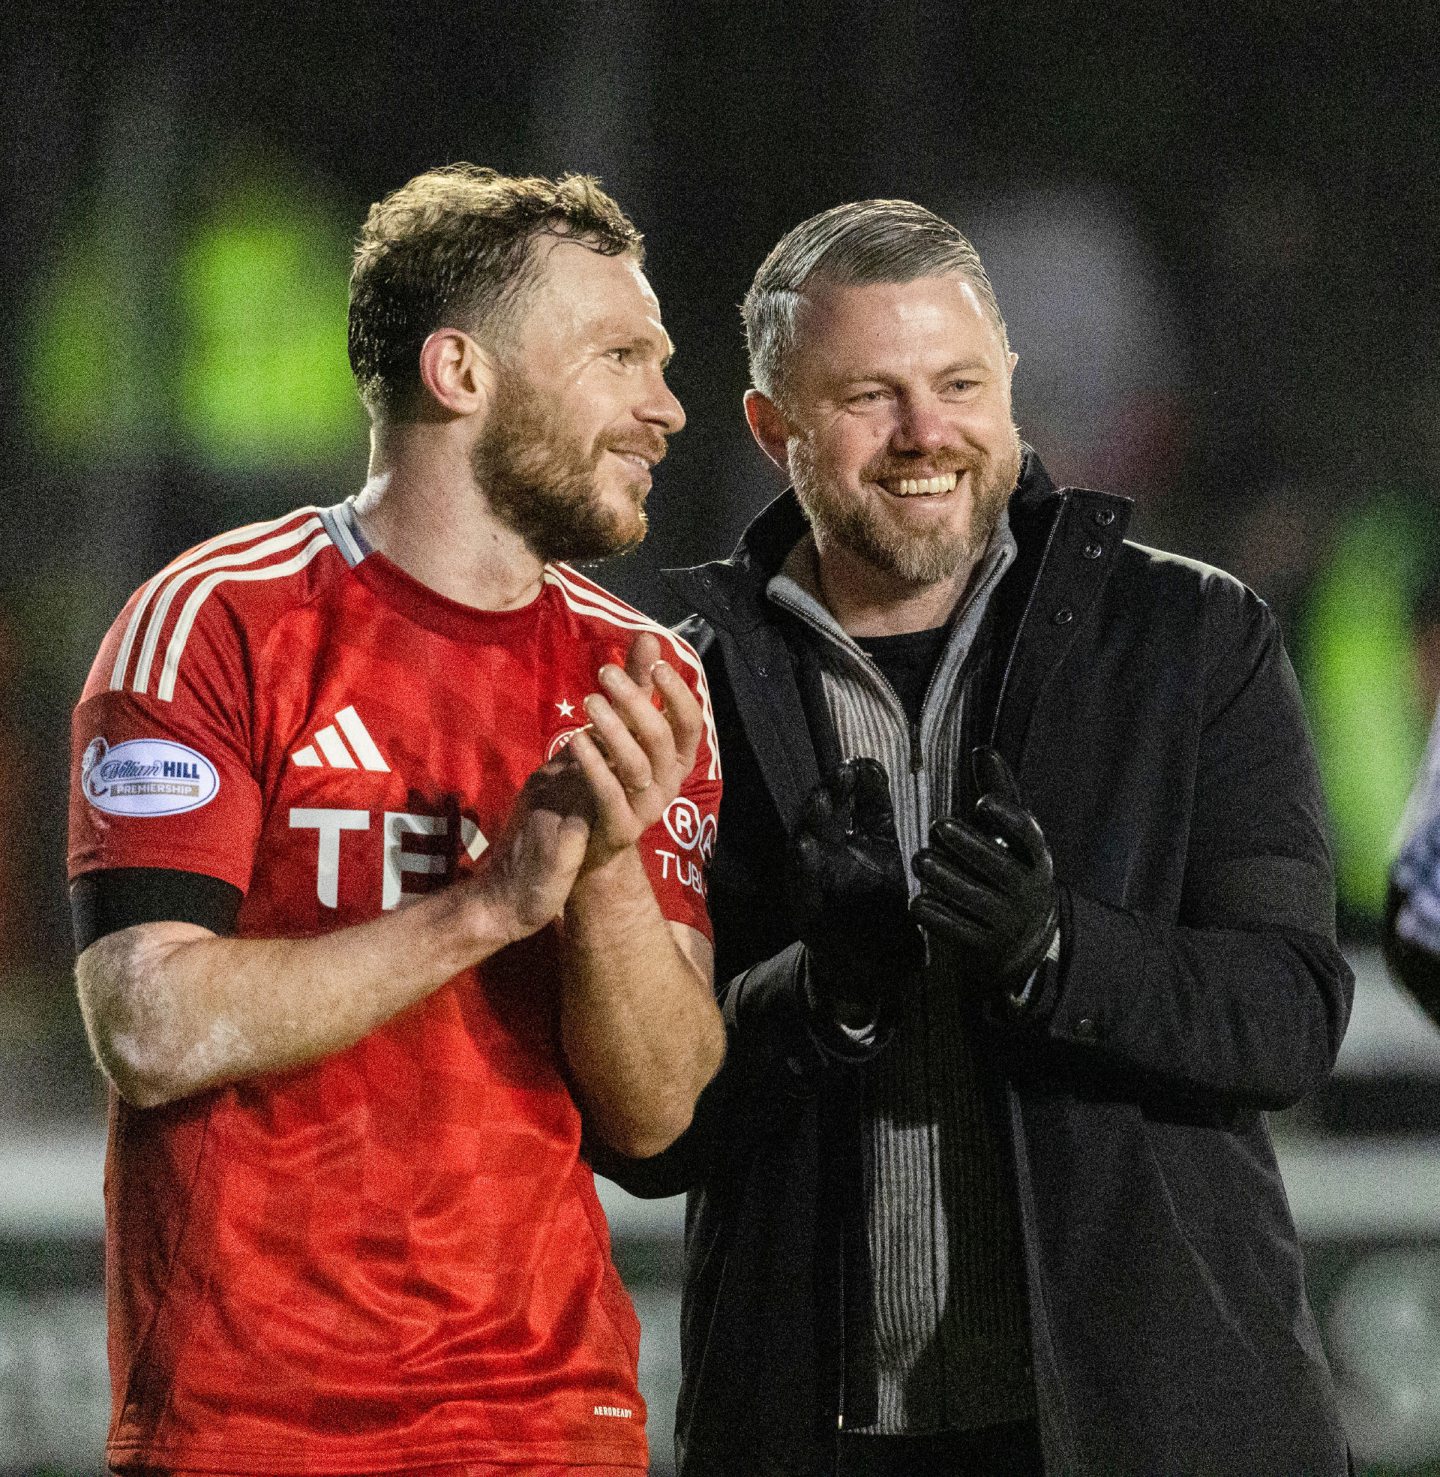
[349,164,644,418]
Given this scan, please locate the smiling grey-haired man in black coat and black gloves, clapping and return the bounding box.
[597,201,1353,1477]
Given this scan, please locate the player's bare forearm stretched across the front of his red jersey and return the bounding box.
[75,889,510,1108]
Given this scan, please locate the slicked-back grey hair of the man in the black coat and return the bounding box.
[740,199,1010,400]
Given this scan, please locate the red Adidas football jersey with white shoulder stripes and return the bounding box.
[69,504,719,1473]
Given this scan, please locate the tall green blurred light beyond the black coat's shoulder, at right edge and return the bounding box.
[1304,502,1433,919]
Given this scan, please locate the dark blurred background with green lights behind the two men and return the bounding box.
[0,0,1440,1474]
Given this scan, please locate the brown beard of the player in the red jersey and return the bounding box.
[471,371,665,563]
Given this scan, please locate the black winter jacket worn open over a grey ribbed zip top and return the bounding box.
[597,453,1353,1477]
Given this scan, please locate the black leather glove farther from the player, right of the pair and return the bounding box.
[910,747,1059,994]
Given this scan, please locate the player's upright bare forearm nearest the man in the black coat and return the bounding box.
[561,849,725,1156]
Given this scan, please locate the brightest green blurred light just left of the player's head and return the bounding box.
[177,189,363,470]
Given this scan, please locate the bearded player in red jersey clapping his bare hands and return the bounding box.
[69,171,722,1474]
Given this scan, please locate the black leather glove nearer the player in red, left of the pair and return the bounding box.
[789,759,925,1027]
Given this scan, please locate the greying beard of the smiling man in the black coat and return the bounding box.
[790,427,1022,585]
